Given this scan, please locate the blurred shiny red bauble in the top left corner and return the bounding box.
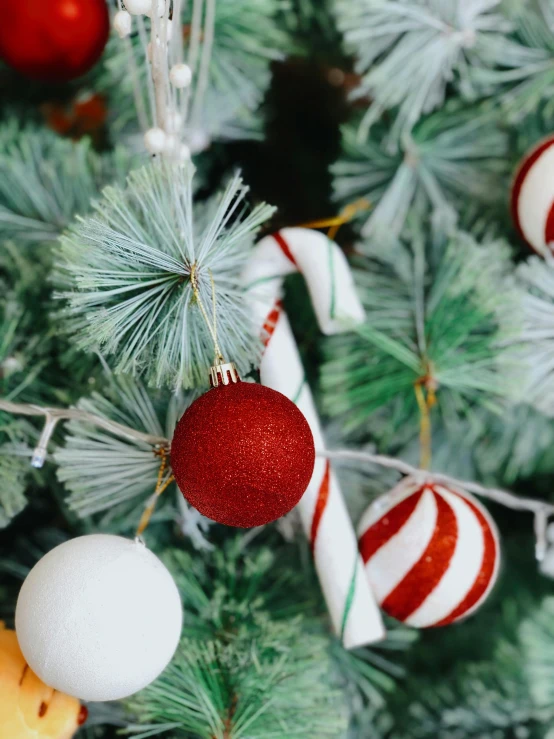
[0,0,110,82]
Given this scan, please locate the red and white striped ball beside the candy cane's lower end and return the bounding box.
[358,478,500,628]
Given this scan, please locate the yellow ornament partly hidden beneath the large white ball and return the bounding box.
[0,621,87,739]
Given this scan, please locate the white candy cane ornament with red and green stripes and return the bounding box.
[244,228,385,649]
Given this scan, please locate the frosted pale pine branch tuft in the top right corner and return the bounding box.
[336,0,552,142]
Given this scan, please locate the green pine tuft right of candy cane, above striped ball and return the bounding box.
[322,225,521,448]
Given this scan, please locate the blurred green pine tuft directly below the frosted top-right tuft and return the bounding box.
[331,103,510,238]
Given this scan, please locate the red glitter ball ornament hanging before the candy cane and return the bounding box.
[171,364,315,528]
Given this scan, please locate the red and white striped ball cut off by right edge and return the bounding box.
[511,135,554,256]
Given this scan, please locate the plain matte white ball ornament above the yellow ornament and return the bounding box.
[15,534,183,701]
